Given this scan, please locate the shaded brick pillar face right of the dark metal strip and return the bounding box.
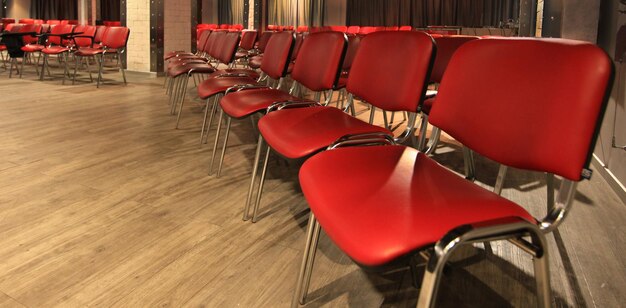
[163,0,191,61]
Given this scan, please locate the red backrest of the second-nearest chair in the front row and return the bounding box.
[346,31,435,112]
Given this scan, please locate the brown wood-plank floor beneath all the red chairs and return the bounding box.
[0,63,626,307]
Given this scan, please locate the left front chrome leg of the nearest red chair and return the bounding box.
[291,213,320,308]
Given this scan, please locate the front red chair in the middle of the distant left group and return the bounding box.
[37,24,74,84]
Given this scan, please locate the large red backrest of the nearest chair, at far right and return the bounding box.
[429,38,613,181]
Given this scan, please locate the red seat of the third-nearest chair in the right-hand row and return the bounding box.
[220,89,300,119]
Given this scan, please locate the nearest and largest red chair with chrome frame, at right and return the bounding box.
[293,39,612,307]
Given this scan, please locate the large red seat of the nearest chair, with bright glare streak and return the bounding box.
[300,146,535,266]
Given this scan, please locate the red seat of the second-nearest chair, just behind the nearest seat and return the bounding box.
[259,107,392,158]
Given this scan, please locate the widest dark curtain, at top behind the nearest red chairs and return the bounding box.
[346,0,520,27]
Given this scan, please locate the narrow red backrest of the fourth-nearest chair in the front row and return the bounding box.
[261,32,295,79]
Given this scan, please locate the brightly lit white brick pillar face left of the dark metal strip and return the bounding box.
[126,0,150,72]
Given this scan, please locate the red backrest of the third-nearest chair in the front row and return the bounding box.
[291,32,346,91]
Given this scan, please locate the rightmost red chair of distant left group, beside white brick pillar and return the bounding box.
[74,27,130,88]
